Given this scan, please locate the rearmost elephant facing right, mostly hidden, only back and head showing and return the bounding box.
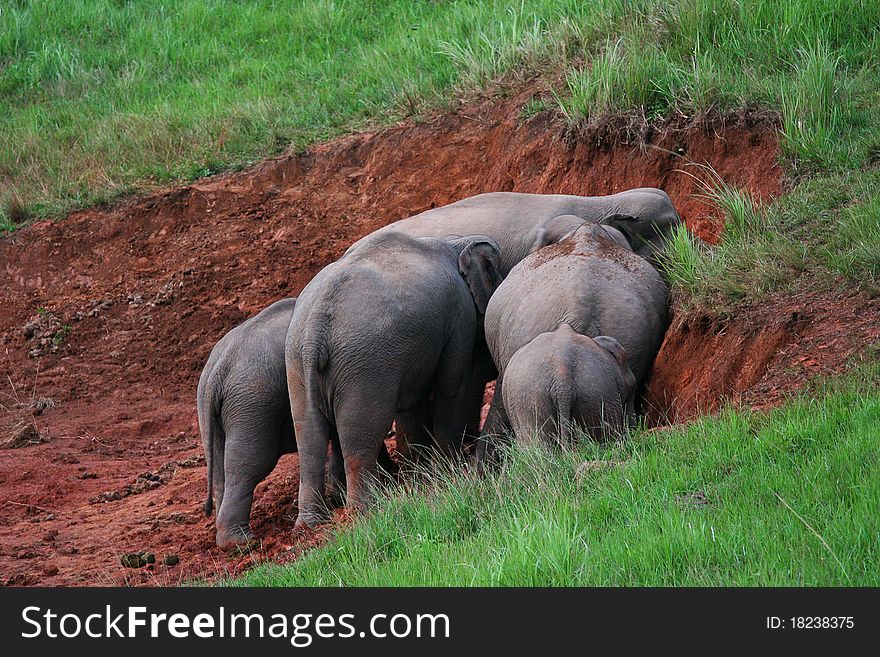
[355,187,681,276]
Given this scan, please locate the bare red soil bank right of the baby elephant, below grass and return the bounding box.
[647,291,880,423]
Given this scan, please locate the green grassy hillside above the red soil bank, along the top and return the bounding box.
[0,0,880,230]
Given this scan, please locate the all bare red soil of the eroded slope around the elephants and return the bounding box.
[0,86,877,585]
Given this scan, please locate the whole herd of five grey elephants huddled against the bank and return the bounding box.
[197,188,681,547]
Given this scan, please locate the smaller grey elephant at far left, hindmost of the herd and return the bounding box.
[196,299,394,547]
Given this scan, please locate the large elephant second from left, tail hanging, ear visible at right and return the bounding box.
[285,232,501,526]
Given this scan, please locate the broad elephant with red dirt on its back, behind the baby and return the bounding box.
[480,225,668,462]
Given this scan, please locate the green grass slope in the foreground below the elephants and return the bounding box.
[230,364,880,586]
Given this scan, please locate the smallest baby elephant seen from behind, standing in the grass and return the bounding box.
[502,324,636,445]
